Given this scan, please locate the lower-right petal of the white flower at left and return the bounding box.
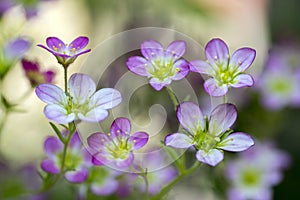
[78,107,108,123]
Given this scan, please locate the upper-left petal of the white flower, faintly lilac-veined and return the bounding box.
[35,84,68,105]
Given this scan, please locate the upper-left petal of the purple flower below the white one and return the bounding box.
[87,132,111,151]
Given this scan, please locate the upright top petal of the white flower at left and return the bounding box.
[68,73,96,104]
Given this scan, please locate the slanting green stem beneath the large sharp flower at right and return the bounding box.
[151,160,201,200]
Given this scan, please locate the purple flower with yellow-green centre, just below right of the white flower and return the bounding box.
[87,117,149,169]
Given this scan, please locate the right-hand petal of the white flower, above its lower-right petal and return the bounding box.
[89,88,122,109]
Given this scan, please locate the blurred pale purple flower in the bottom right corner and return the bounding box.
[226,143,290,200]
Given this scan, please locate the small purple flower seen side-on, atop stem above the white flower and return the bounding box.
[38,36,91,68]
